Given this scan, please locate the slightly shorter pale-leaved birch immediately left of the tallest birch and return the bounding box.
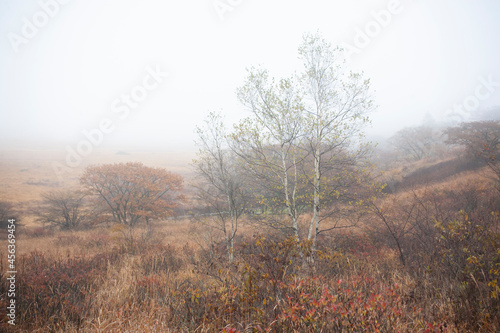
[231,68,304,239]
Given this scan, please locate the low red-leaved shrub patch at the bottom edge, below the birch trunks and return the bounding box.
[275,275,445,332]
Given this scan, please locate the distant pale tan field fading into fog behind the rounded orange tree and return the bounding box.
[0,149,195,226]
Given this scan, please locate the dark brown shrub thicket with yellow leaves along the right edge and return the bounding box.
[378,183,500,332]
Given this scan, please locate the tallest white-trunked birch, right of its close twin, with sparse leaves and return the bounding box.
[299,34,372,244]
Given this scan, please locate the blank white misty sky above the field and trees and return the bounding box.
[0,0,500,150]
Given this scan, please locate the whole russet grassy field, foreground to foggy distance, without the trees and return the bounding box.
[0,151,500,332]
